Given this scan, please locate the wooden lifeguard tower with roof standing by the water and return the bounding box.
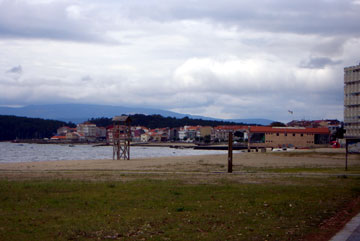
[112,116,131,160]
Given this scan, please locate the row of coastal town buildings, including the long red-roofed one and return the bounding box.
[49,120,342,148]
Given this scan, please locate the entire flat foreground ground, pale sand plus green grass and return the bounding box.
[0,149,360,240]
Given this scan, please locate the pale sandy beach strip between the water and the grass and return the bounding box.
[0,148,360,180]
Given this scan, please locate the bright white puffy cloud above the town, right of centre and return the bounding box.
[174,56,333,94]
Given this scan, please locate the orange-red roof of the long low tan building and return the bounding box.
[250,126,330,134]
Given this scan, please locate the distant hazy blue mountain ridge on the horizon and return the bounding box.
[0,104,273,125]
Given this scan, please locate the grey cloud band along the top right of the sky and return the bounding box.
[119,0,360,36]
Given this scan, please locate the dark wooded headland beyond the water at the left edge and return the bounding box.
[0,115,75,141]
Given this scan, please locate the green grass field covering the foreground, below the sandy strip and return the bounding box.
[0,178,360,240]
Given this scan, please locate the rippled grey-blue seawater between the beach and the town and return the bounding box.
[0,142,239,162]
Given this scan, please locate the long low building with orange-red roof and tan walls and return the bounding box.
[250,126,330,148]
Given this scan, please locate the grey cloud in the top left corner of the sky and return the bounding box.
[0,0,112,42]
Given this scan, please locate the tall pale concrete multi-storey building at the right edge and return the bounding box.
[344,64,360,138]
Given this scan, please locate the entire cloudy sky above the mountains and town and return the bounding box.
[0,0,360,121]
